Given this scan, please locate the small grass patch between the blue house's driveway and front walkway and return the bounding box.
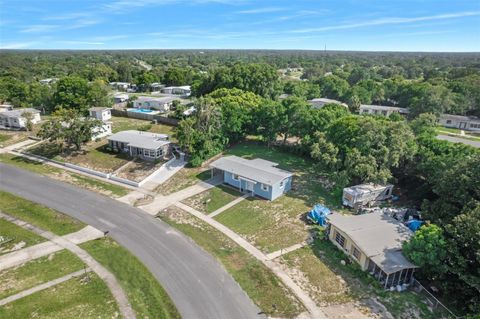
[182,185,243,214]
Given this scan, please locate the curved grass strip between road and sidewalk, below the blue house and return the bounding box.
[159,207,304,318]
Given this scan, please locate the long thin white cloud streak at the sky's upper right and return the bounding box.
[291,11,480,33]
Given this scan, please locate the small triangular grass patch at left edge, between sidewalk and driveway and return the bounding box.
[0,219,45,256]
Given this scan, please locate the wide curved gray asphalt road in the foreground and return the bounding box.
[0,163,261,319]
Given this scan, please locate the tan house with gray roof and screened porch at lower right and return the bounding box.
[327,212,418,288]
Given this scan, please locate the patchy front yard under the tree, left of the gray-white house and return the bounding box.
[28,140,131,173]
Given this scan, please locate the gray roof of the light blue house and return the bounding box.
[210,156,293,185]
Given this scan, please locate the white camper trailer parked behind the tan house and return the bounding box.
[342,184,393,208]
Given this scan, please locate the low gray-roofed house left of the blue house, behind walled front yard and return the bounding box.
[108,130,171,160]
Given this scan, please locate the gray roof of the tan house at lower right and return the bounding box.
[327,212,416,273]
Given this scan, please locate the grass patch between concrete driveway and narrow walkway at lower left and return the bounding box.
[0,250,84,299]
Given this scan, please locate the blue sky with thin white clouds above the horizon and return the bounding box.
[0,0,480,52]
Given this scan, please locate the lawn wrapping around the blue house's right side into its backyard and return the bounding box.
[215,141,342,253]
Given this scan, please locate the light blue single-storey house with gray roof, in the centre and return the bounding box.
[210,156,293,200]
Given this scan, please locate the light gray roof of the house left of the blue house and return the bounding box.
[108,130,170,149]
